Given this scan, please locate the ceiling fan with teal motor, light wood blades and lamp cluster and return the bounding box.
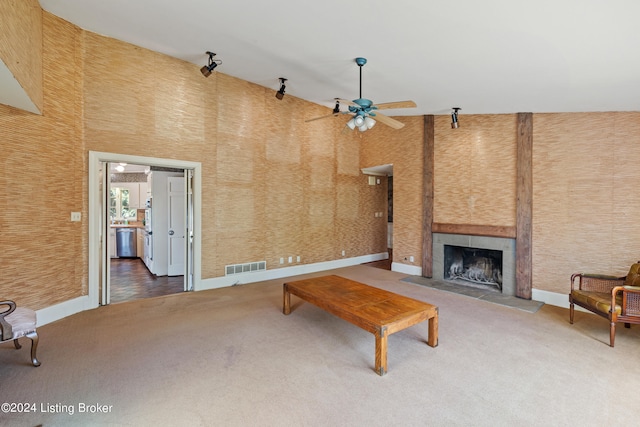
[306,58,416,132]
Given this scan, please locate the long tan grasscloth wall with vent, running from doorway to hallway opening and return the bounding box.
[84,28,386,278]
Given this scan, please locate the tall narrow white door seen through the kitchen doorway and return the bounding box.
[167,177,186,276]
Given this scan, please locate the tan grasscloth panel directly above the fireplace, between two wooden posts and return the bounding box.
[433,114,517,226]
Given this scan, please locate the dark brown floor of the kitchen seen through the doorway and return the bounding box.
[110,258,184,304]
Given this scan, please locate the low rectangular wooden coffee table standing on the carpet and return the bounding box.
[282,276,438,375]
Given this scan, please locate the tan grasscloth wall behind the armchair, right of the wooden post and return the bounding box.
[533,112,640,293]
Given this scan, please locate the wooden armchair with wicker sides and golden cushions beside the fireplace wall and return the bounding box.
[569,261,640,347]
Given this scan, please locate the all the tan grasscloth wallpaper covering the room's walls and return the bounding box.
[0,0,640,309]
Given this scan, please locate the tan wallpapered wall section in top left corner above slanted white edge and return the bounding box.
[0,0,44,111]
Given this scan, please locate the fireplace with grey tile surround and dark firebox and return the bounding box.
[433,233,516,296]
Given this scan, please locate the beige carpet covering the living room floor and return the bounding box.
[0,266,640,426]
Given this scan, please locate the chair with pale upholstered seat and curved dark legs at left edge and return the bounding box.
[0,301,40,366]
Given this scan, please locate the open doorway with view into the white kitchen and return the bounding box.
[107,162,187,304]
